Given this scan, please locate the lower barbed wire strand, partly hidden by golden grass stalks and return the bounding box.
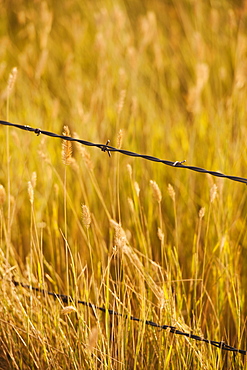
[11,280,247,355]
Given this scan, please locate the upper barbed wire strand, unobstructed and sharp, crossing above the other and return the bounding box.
[0,120,247,184]
